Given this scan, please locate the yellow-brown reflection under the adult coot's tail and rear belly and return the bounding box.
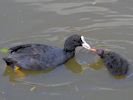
[3,66,54,82]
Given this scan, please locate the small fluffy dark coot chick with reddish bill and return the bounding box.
[90,49,129,76]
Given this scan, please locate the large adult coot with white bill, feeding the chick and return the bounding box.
[3,34,89,70]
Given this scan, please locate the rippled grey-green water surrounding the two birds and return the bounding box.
[0,0,133,100]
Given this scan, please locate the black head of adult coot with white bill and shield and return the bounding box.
[64,34,89,51]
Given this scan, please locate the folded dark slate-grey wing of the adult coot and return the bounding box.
[8,44,67,70]
